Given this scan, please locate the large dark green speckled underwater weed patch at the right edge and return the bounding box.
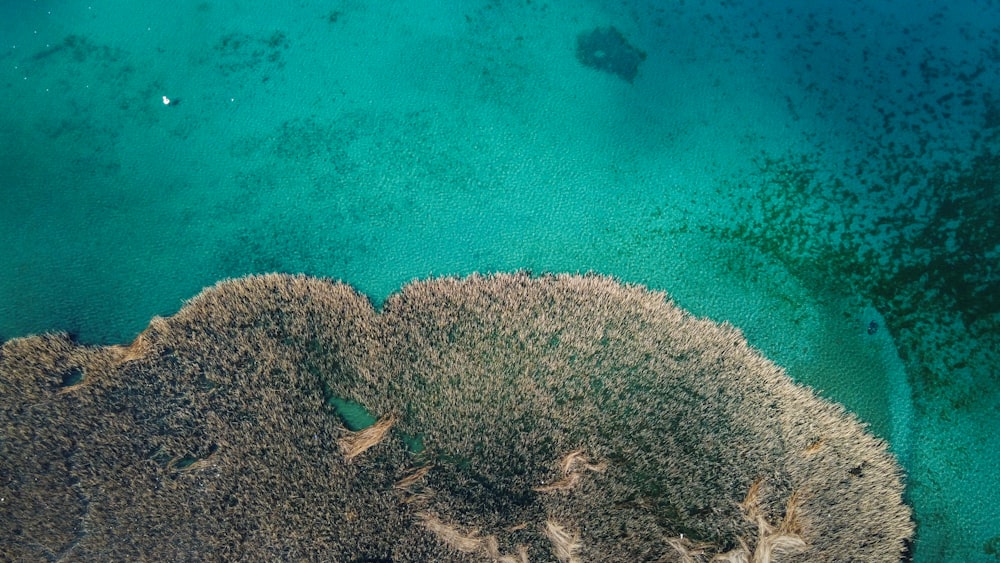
[709,145,1000,409]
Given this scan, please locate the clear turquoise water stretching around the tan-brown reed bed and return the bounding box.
[0,0,1000,562]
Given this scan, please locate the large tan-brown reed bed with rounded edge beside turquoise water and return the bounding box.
[0,273,913,562]
